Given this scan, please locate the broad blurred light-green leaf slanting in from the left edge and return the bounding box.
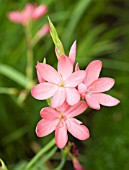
[0,64,27,88]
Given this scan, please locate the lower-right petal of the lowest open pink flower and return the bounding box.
[67,118,90,140]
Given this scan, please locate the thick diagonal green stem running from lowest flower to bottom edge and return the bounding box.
[26,139,55,170]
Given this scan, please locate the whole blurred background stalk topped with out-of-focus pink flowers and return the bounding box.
[7,3,50,103]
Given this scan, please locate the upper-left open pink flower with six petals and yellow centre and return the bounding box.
[32,56,85,108]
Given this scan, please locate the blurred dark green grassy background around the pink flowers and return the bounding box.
[0,0,129,170]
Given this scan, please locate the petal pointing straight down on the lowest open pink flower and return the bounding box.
[55,121,68,149]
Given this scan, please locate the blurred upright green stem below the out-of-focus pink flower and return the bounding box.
[24,23,33,88]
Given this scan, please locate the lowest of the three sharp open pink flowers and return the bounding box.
[36,101,89,148]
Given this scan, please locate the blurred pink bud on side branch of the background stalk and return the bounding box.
[37,24,50,38]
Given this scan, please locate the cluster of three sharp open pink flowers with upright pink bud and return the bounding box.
[32,42,119,148]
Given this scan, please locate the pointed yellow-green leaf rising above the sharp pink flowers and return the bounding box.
[48,17,64,55]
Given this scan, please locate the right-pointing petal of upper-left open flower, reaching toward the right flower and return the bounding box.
[65,70,86,87]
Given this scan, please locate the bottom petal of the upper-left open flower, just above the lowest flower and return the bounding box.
[51,87,66,108]
